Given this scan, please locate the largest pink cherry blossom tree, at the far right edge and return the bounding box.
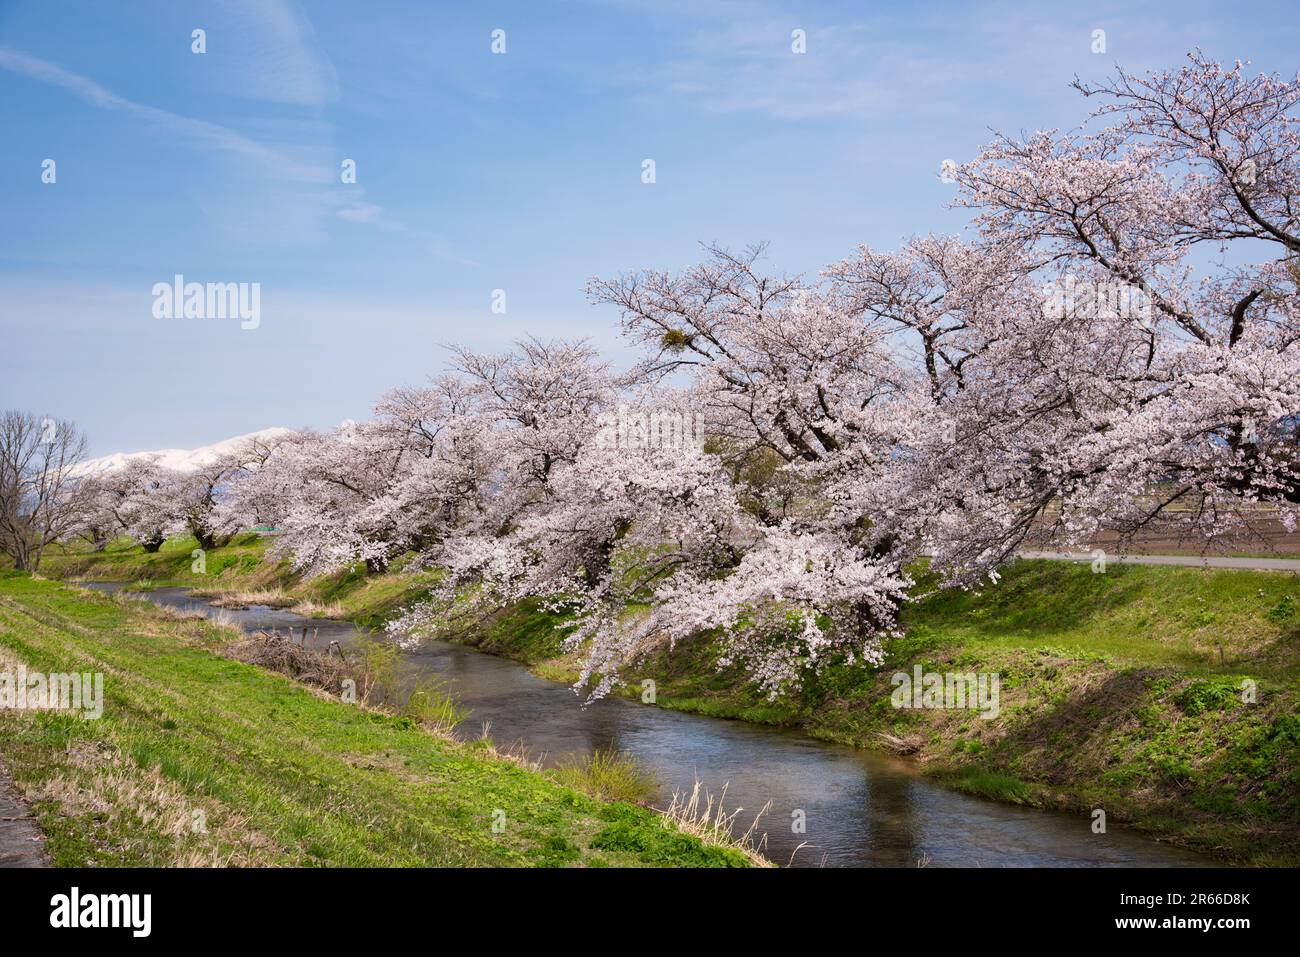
[831,53,1300,584]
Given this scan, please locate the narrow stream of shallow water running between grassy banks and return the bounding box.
[85,583,1214,867]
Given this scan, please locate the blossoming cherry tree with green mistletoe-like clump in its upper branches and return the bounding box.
[566,247,927,694]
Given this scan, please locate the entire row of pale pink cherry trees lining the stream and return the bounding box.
[73,55,1300,694]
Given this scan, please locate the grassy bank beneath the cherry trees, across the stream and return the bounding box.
[35,537,1300,865]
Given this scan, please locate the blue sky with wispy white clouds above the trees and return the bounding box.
[0,0,1300,454]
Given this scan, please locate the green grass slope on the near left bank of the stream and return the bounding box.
[0,572,745,866]
